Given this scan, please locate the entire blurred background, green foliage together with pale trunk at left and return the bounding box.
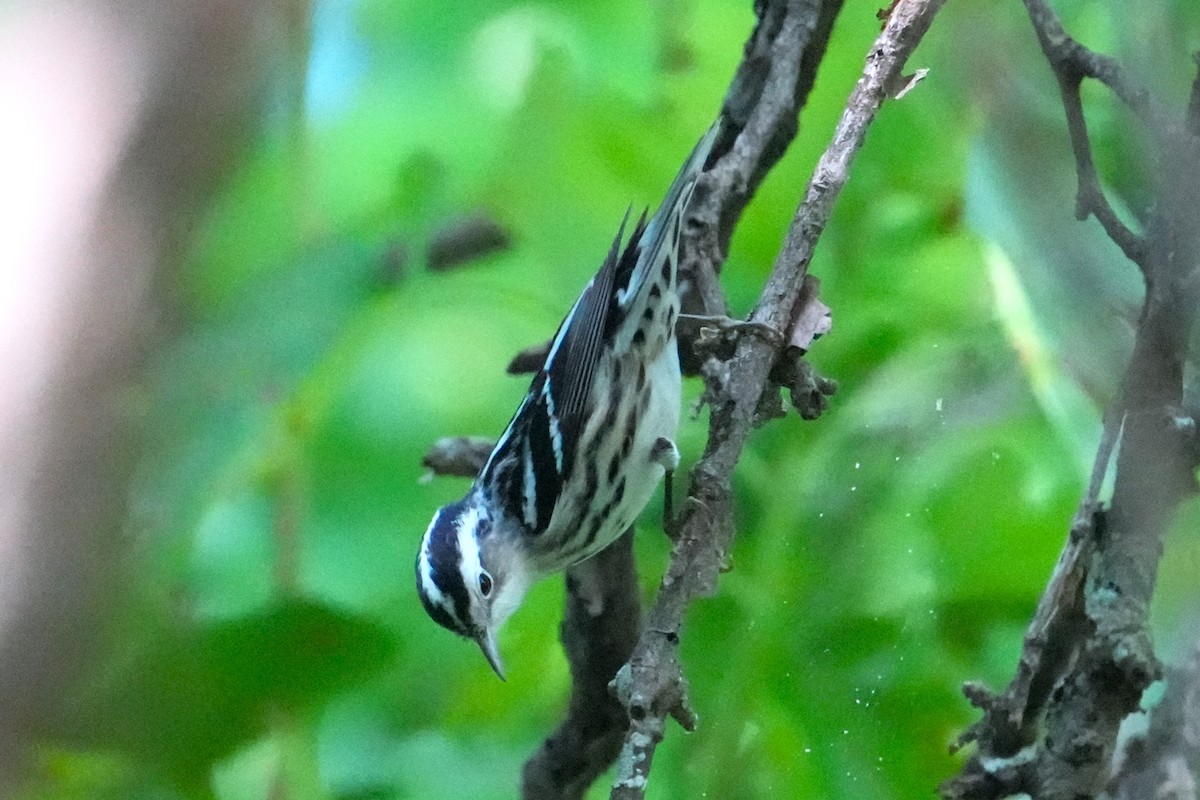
[7,0,1200,800]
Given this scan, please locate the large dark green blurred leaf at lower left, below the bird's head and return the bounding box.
[59,600,397,790]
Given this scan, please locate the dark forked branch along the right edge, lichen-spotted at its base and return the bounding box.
[941,0,1200,800]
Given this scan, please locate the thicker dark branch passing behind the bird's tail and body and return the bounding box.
[523,0,841,800]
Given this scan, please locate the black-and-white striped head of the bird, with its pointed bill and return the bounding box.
[416,493,530,680]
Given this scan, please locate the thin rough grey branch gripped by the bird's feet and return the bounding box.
[612,0,942,800]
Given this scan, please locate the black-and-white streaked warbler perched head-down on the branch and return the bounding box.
[416,125,718,679]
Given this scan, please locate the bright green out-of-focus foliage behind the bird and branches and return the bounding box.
[20,0,1196,800]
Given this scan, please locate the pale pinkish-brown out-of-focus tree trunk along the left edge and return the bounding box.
[0,0,283,790]
